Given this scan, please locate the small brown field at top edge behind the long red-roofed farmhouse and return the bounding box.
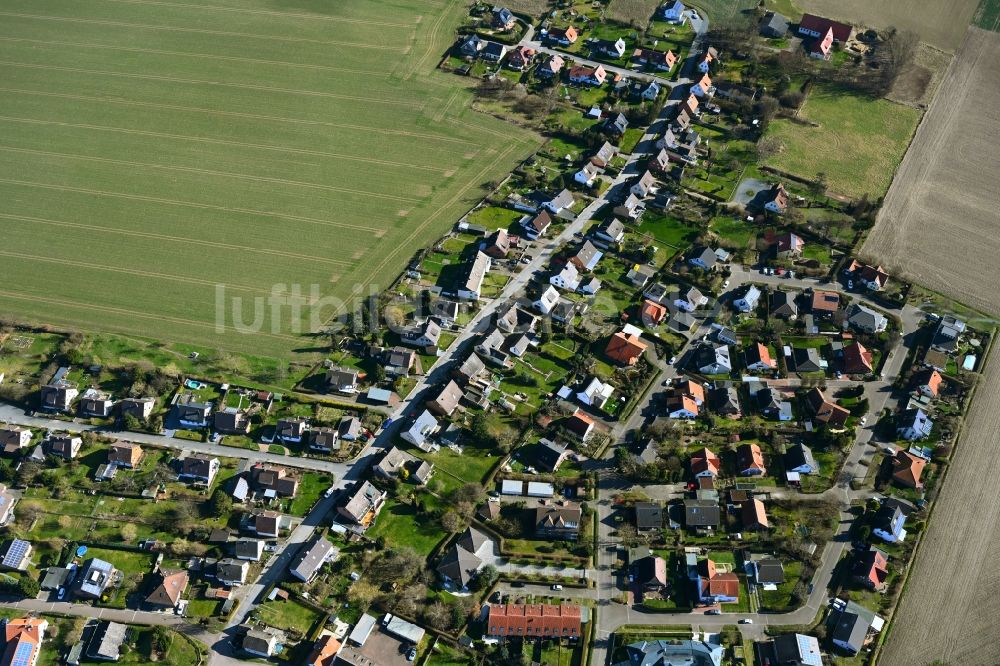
[798,0,979,51]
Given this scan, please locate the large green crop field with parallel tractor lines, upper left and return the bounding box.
[0,0,537,356]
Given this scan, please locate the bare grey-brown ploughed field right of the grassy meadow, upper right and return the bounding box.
[864,28,1000,314]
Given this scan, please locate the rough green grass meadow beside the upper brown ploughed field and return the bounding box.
[767,88,921,197]
